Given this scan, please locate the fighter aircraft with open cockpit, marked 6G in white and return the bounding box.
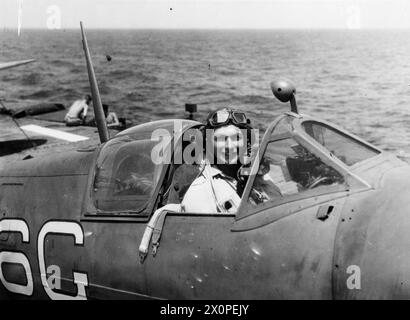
[0,23,410,299]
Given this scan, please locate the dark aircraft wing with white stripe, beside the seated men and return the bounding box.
[0,99,123,168]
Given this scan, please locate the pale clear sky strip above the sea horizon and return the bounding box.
[0,0,410,30]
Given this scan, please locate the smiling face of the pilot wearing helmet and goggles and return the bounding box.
[214,125,244,164]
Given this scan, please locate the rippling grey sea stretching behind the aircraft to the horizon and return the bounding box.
[0,29,410,155]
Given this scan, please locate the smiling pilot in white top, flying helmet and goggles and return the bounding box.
[159,108,252,213]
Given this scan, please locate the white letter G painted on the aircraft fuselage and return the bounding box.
[37,221,88,300]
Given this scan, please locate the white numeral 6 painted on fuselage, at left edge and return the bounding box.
[0,219,33,296]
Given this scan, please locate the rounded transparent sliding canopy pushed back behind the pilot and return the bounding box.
[93,120,200,213]
